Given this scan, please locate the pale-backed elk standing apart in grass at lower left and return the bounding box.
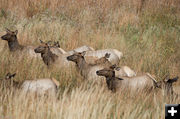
[1,73,59,95]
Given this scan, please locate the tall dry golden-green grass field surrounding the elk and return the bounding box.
[0,0,180,119]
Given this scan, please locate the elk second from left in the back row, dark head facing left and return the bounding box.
[34,43,74,68]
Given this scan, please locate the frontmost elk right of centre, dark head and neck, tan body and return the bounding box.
[96,65,157,91]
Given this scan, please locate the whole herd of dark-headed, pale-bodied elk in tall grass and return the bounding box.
[0,29,178,98]
